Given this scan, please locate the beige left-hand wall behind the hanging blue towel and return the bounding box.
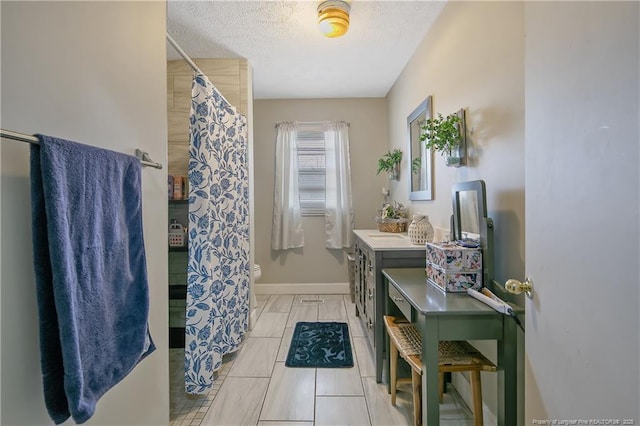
[0,2,169,426]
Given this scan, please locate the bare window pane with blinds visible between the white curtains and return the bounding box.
[296,123,325,216]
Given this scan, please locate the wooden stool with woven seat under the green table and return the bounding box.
[383,315,496,426]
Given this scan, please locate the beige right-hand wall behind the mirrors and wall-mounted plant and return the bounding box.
[387,2,525,420]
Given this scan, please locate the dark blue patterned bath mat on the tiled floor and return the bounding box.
[285,322,353,368]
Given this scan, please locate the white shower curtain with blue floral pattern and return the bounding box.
[185,73,250,394]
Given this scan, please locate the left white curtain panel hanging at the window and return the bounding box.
[271,122,304,250]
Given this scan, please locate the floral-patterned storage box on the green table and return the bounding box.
[426,242,482,293]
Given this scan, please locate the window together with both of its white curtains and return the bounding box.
[271,121,353,250]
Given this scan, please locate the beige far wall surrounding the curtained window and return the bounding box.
[254,98,389,291]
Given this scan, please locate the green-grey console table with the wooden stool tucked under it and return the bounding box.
[382,268,524,426]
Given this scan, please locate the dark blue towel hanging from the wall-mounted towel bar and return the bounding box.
[31,135,155,424]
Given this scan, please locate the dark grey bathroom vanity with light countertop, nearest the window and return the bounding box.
[353,229,426,382]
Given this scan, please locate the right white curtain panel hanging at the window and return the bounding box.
[324,122,353,249]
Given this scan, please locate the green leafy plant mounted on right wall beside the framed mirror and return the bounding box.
[420,109,465,167]
